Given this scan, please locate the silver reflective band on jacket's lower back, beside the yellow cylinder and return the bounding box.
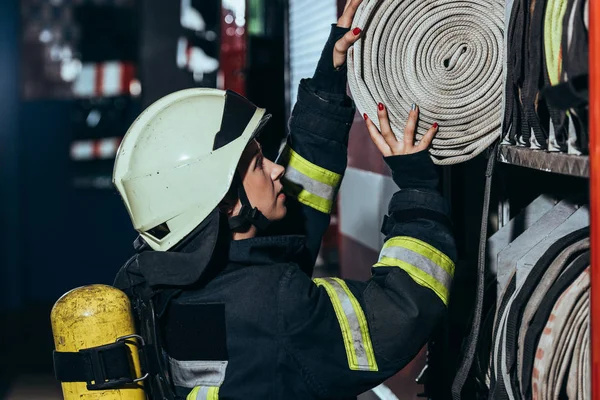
[169,357,227,388]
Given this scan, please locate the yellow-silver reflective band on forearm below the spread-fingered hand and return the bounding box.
[375,236,454,305]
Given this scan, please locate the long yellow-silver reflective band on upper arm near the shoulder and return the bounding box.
[314,278,378,371]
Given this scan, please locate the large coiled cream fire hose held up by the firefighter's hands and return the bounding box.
[348,0,504,165]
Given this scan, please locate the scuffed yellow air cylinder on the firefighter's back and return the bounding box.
[50,285,146,400]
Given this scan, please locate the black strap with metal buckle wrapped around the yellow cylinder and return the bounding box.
[53,341,138,390]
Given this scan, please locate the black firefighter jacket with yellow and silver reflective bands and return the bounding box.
[115,28,456,400]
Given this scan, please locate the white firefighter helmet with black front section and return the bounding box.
[113,88,269,251]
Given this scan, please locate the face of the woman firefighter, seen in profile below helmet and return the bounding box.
[234,140,287,221]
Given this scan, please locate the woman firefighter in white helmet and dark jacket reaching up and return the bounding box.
[114,0,456,400]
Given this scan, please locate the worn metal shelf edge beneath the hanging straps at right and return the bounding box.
[498,145,590,178]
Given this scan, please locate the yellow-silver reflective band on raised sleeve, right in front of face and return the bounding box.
[282,146,342,214]
